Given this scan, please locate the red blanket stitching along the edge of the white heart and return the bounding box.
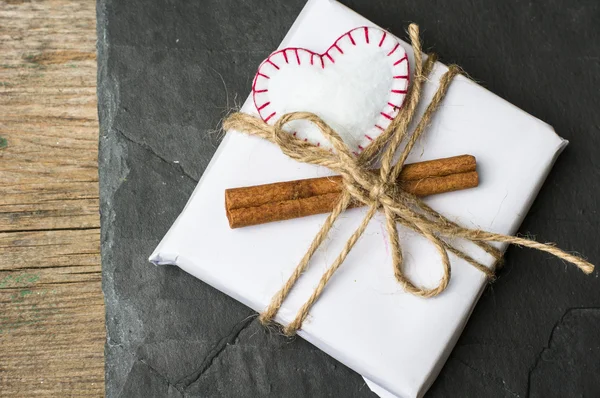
[252,26,410,154]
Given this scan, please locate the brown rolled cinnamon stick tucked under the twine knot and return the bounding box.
[225,155,479,228]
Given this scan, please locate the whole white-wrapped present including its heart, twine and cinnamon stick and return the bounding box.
[150,0,591,397]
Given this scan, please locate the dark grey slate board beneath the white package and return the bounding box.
[98,0,600,397]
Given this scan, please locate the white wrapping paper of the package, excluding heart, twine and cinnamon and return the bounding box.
[150,0,567,397]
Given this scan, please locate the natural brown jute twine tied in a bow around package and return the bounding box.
[223,24,594,335]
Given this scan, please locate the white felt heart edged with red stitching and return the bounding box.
[252,26,409,153]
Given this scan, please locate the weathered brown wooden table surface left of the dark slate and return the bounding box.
[0,0,105,396]
